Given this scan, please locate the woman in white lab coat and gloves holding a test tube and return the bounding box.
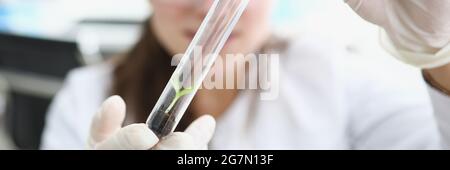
[43,0,450,149]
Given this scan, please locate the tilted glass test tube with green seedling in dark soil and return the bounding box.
[147,0,250,138]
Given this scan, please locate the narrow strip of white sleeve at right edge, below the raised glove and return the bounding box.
[428,86,450,149]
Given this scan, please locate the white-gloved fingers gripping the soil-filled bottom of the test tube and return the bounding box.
[88,96,215,150]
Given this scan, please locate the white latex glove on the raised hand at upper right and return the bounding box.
[345,0,450,68]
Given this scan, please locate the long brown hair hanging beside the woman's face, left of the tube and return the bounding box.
[112,19,190,129]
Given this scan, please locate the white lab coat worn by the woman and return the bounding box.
[42,34,450,149]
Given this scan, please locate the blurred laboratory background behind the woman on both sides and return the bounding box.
[0,0,383,149]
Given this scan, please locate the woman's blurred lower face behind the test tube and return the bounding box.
[150,0,273,55]
